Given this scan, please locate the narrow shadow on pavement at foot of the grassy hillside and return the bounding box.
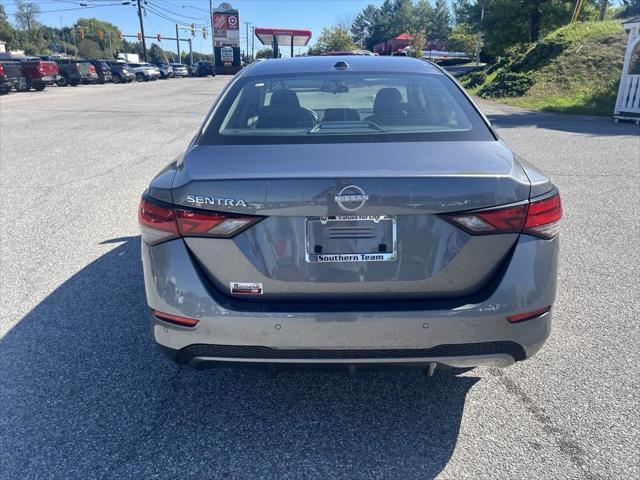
[488,109,640,136]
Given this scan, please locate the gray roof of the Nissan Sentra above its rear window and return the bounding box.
[238,55,441,76]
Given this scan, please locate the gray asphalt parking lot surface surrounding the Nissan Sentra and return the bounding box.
[0,77,640,479]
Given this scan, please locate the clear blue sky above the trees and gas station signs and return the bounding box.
[0,0,390,55]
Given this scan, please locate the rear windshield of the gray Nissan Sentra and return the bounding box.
[198,72,495,144]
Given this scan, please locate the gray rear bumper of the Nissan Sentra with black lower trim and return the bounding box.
[142,235,559,367]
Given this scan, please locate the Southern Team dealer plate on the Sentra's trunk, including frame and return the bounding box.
[305,216,397,263]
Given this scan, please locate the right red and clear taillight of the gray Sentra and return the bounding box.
[443,192,562,239]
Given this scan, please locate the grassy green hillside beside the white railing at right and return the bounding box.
[462,20,627,115]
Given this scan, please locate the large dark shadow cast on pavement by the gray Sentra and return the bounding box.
[0,237,478,479]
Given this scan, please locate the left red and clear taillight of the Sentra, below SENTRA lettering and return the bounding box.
[138,197,263,245]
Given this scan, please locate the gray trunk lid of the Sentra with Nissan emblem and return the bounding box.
[169,141,530,300]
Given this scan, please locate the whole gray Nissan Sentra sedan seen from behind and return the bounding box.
[139,56,562,371]
